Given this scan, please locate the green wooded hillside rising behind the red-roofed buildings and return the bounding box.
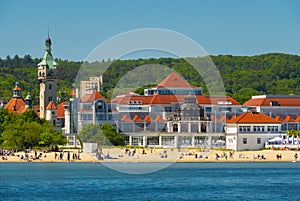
[0,53,300,104]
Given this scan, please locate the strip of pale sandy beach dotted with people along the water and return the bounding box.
[0,147,300,162]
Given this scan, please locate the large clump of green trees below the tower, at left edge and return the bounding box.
[0,109,67,150]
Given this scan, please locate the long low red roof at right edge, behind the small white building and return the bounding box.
[243,96,300,106]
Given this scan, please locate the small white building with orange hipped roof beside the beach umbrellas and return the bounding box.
[225,111,282,151]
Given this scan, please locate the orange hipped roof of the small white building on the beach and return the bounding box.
[227,112,281,124]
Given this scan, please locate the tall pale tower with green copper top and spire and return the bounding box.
[38,36,58,118]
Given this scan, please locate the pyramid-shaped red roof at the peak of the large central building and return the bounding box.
[157,72,192,88]
